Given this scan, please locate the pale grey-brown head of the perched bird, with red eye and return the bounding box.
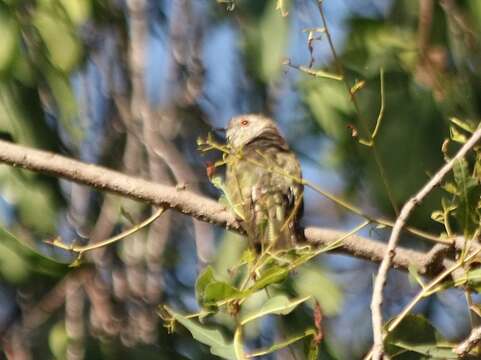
[226,114,281,149]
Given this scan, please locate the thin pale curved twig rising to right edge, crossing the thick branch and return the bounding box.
[371,127,481,360]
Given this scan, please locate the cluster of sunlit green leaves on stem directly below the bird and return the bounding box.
[161,243,326,359]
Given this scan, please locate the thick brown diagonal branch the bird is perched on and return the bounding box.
[0,140,448,275]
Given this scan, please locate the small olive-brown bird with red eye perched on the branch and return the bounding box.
[225,114,304,251]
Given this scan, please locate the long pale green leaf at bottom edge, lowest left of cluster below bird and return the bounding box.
[165,307,236,360]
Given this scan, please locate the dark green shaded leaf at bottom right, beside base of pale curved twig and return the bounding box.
[385,315,456,359]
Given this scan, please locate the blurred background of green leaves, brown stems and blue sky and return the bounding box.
[0,0,481,359]
